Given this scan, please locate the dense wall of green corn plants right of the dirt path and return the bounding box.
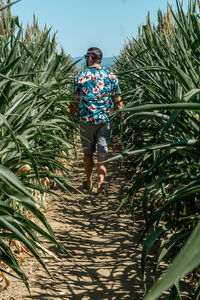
[112,1,200,299]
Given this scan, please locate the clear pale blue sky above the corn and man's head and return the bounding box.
[12,0,188,57]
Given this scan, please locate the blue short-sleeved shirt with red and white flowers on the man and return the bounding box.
[74,67,121,124]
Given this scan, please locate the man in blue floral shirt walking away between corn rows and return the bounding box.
[70,47,123,194]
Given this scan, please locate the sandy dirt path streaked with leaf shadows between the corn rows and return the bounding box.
[0,144,189,300]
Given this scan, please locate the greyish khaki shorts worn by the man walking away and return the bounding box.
[80,122,112,154]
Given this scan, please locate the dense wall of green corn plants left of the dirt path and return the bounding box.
[0,1,75,289]
